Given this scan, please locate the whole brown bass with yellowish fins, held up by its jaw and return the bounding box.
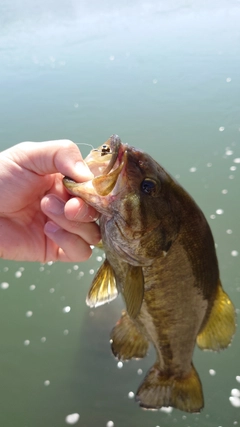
[63,135,236,413]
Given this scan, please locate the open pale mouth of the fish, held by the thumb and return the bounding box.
[63,135,127,206]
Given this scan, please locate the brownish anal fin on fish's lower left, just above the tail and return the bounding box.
[111,312,149,360]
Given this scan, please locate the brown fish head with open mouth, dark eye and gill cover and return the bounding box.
[63,135,177,265]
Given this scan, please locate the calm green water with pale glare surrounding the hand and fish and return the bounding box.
[0,0,240,427]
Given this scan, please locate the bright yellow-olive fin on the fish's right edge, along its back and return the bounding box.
[197,281,236,351]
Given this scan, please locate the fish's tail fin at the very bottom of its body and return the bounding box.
[136,363,204,412]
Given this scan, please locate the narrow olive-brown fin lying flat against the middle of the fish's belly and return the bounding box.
[123,264,144,319]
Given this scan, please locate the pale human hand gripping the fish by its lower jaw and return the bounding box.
[0,140,100,263]
